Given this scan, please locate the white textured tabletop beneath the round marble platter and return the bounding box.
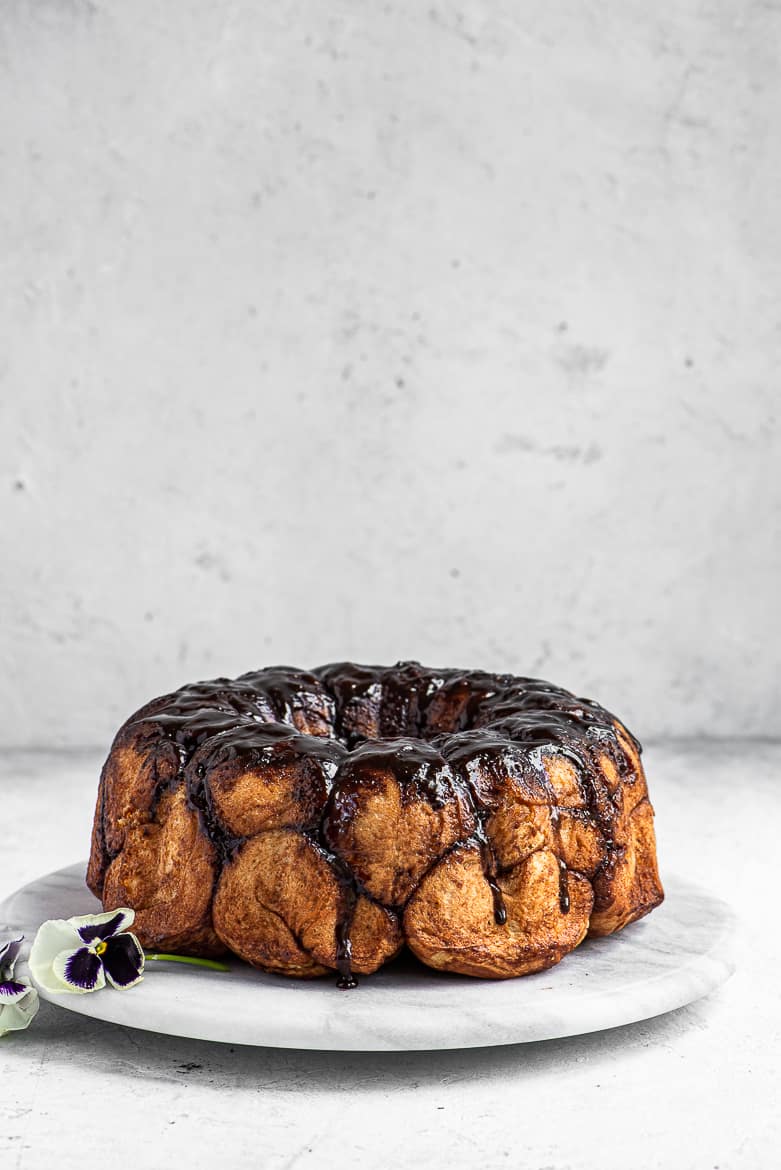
[0,743,781,1170]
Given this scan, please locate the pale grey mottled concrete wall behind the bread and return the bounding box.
[0,0,781,744]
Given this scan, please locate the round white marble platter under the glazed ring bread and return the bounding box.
[0,862,734,1052]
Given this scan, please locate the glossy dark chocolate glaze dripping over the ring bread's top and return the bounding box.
[112,662,641,987]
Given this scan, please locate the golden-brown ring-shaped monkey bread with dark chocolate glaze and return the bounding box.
[87,662,664,986]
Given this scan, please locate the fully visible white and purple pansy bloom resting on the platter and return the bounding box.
[29,907,144,995]
